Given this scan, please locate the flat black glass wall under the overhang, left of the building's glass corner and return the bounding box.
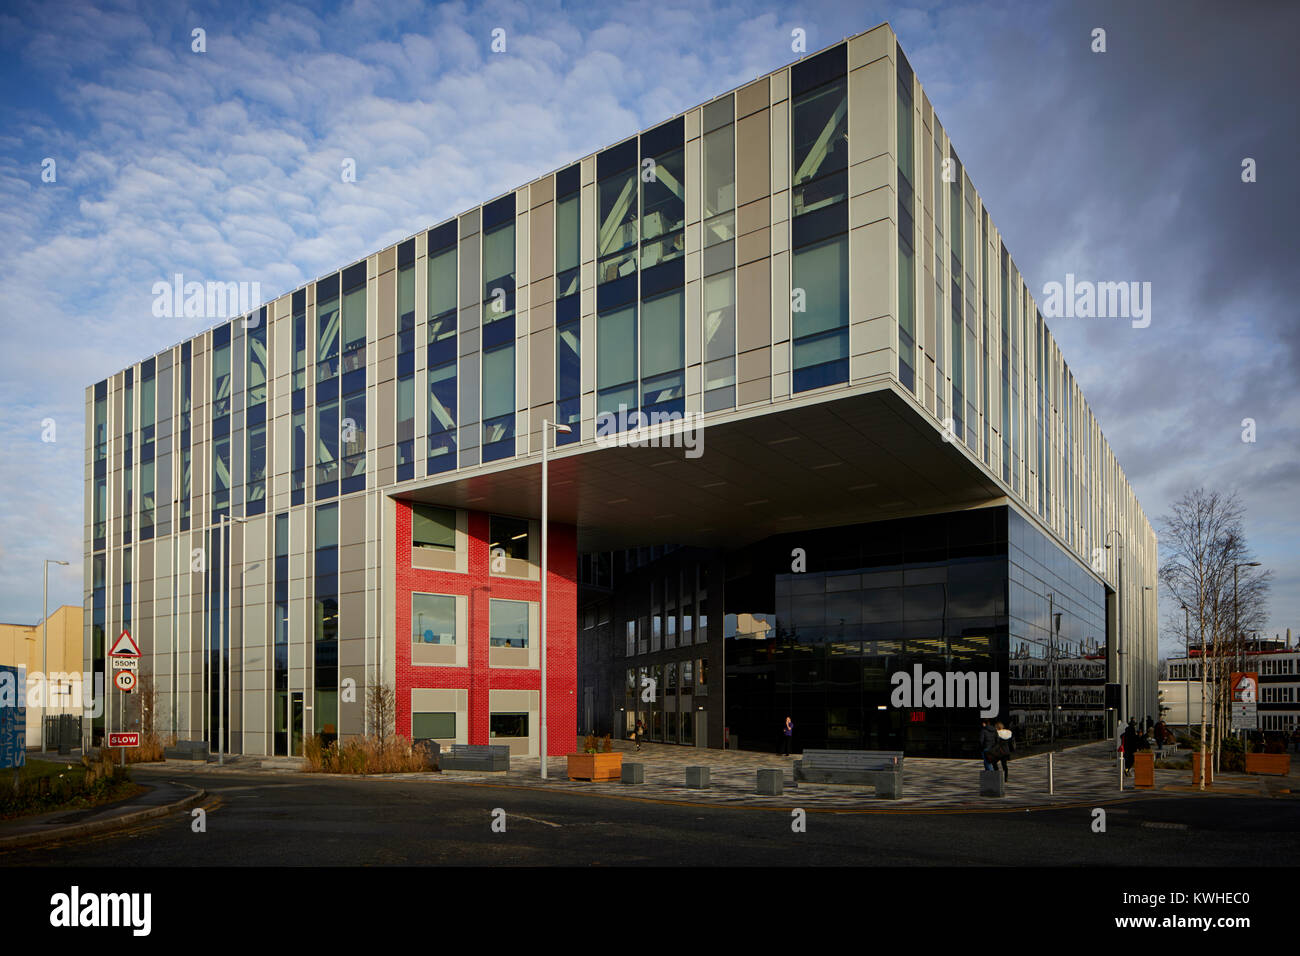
[724,509,1008,756]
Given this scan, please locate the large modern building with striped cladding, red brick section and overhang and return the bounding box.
[86,25,1156,754]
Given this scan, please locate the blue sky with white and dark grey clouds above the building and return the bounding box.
[0,0,1300,658]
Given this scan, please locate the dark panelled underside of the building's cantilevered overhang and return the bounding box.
[390,382,1005,551]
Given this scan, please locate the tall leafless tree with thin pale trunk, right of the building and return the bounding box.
[1160,488,1269,790]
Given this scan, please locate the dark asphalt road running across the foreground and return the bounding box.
[0,770,1300,868]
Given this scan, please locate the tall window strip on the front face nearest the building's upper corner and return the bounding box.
[790,46,849,392]
